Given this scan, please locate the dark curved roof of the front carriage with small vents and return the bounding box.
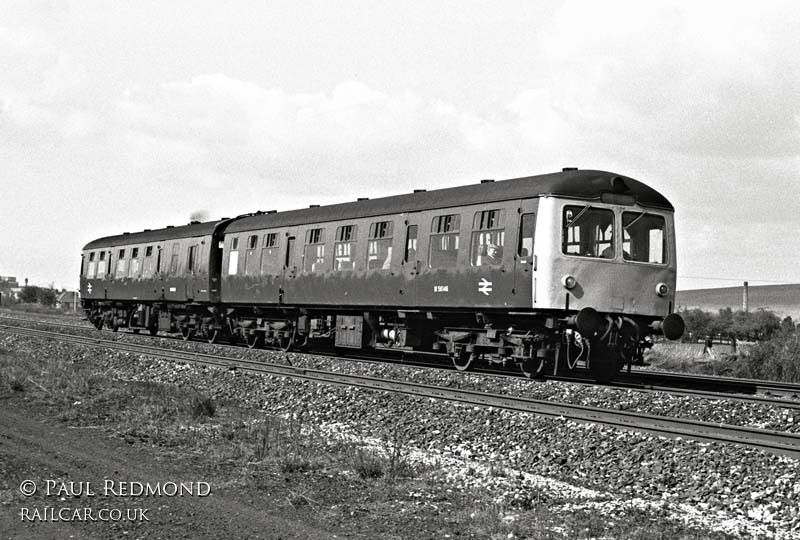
[225,170,674,233]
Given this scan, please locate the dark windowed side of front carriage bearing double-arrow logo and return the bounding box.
[222,199,537,309]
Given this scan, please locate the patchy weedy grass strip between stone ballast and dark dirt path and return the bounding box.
[0,340,736,539]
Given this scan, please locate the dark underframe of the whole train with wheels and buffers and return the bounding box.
[84,301,683,382]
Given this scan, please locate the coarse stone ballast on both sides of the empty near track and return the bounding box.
[0,334,800,538]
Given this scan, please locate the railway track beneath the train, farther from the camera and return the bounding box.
[0,315,800,410]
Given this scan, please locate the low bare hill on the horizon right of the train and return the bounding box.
[675,284,800,321]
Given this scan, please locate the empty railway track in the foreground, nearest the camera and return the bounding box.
[0,325,800,459]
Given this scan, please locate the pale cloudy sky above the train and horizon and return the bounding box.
[0,0,800,289]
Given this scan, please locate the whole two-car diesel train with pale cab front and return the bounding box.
[81,169,683,381]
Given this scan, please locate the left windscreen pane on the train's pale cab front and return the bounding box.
[561,204,614,259]
